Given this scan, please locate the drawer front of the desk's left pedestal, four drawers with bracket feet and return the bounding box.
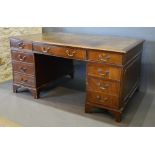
[10,39,37,98]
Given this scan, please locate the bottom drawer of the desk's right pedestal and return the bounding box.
[87,91,119,108]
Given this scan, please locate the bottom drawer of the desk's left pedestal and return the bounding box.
[14,73,35,87]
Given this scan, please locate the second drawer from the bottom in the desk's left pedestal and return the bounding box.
[12,61,34,75]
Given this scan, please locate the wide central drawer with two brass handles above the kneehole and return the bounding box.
[33,43,86,60]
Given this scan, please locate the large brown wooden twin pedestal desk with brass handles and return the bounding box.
[10,32,144,122]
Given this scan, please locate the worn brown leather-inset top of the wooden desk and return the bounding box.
[10,32,144,53]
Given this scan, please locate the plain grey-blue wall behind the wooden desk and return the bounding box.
[43,27,155,93]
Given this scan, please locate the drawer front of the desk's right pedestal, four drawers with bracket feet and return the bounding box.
[85,51,123,121]
